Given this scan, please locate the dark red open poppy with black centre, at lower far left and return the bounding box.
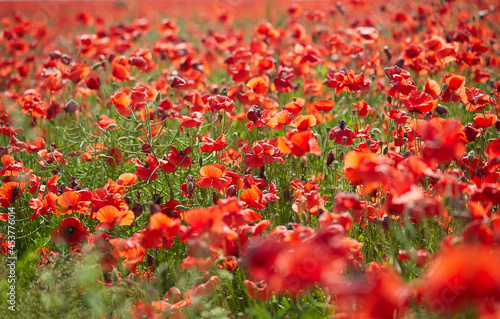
[50,217,89,247]
